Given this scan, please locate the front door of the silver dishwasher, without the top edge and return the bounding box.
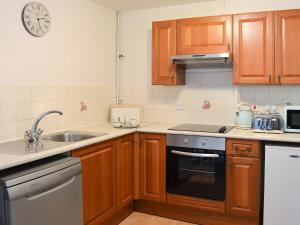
[4,164,83,225]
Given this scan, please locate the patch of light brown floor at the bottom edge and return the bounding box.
[120,212,193,225]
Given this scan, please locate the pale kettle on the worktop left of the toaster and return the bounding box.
[235,102,253,128]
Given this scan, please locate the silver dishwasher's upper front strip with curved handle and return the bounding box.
[4,164,82,201]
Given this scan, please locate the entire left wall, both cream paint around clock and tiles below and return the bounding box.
[0,0,116,141]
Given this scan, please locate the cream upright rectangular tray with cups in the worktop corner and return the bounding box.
[111,105,141,128]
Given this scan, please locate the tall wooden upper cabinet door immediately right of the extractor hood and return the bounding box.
[233,12,274,84]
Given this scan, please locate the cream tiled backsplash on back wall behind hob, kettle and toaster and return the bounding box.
[122,70,300,125]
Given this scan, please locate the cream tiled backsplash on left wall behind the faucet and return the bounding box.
[0,86,115,141]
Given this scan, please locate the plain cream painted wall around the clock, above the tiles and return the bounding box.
[0,0,116,85]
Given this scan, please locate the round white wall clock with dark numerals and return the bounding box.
[22,2,51,37]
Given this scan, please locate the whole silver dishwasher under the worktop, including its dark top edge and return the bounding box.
[0,156,83,225]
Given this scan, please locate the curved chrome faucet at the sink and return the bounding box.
[25,110,63,143]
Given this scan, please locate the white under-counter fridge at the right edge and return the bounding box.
[264,145,300,225]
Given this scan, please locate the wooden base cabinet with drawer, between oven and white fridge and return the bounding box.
[226,139,260,218]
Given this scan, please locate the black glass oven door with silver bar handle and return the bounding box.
[167,146,226,201]
